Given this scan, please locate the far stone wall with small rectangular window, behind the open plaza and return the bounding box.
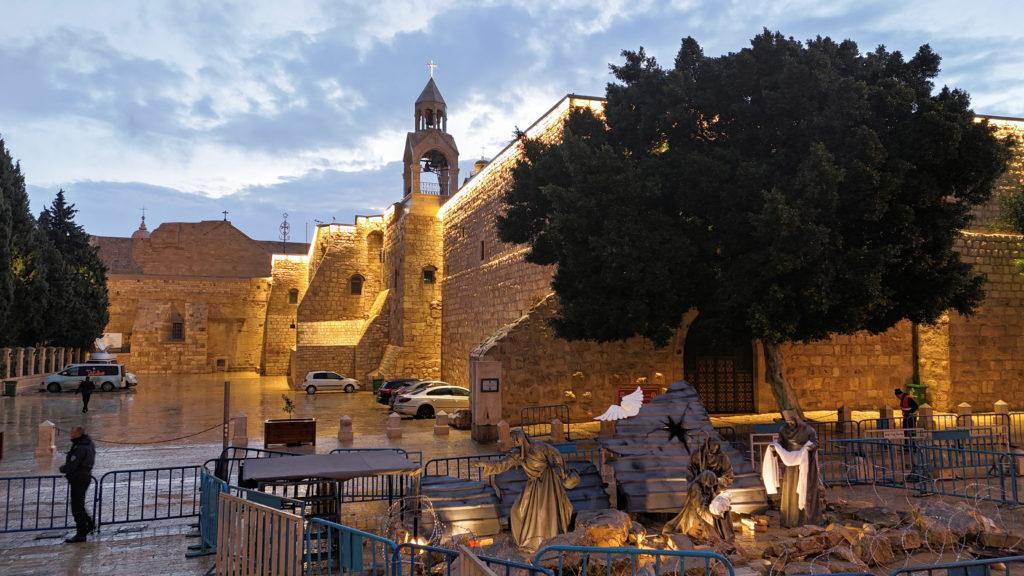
[105,275,270,373]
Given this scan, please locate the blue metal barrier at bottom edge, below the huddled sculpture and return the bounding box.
[534,545,734,576]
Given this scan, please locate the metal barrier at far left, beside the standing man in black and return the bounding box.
[0,476,98,533]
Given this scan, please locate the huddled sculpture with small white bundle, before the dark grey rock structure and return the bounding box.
[662,438,735,542]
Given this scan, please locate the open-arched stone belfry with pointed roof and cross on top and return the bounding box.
[402,61,459,200]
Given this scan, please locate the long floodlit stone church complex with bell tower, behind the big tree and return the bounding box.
[94,73,1024,438]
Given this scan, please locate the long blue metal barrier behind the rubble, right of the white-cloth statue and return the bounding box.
[820,433,1024,504]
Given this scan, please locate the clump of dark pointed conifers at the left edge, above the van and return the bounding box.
[0,139,108,347]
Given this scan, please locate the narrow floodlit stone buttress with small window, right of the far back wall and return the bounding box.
[262,256,308,375]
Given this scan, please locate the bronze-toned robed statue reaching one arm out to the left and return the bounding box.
[476,427,580,553]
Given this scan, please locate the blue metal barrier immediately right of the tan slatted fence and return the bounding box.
[304,518,398,576]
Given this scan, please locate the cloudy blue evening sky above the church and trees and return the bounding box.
[0,0,1024,242]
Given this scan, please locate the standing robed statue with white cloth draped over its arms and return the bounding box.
[761,410,824,528]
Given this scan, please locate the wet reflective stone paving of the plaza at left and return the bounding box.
[0,373,496,575]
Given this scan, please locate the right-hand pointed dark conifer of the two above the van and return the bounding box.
[39,190,108,347]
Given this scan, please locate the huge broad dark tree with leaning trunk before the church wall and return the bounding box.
[498,31,1011,410]
